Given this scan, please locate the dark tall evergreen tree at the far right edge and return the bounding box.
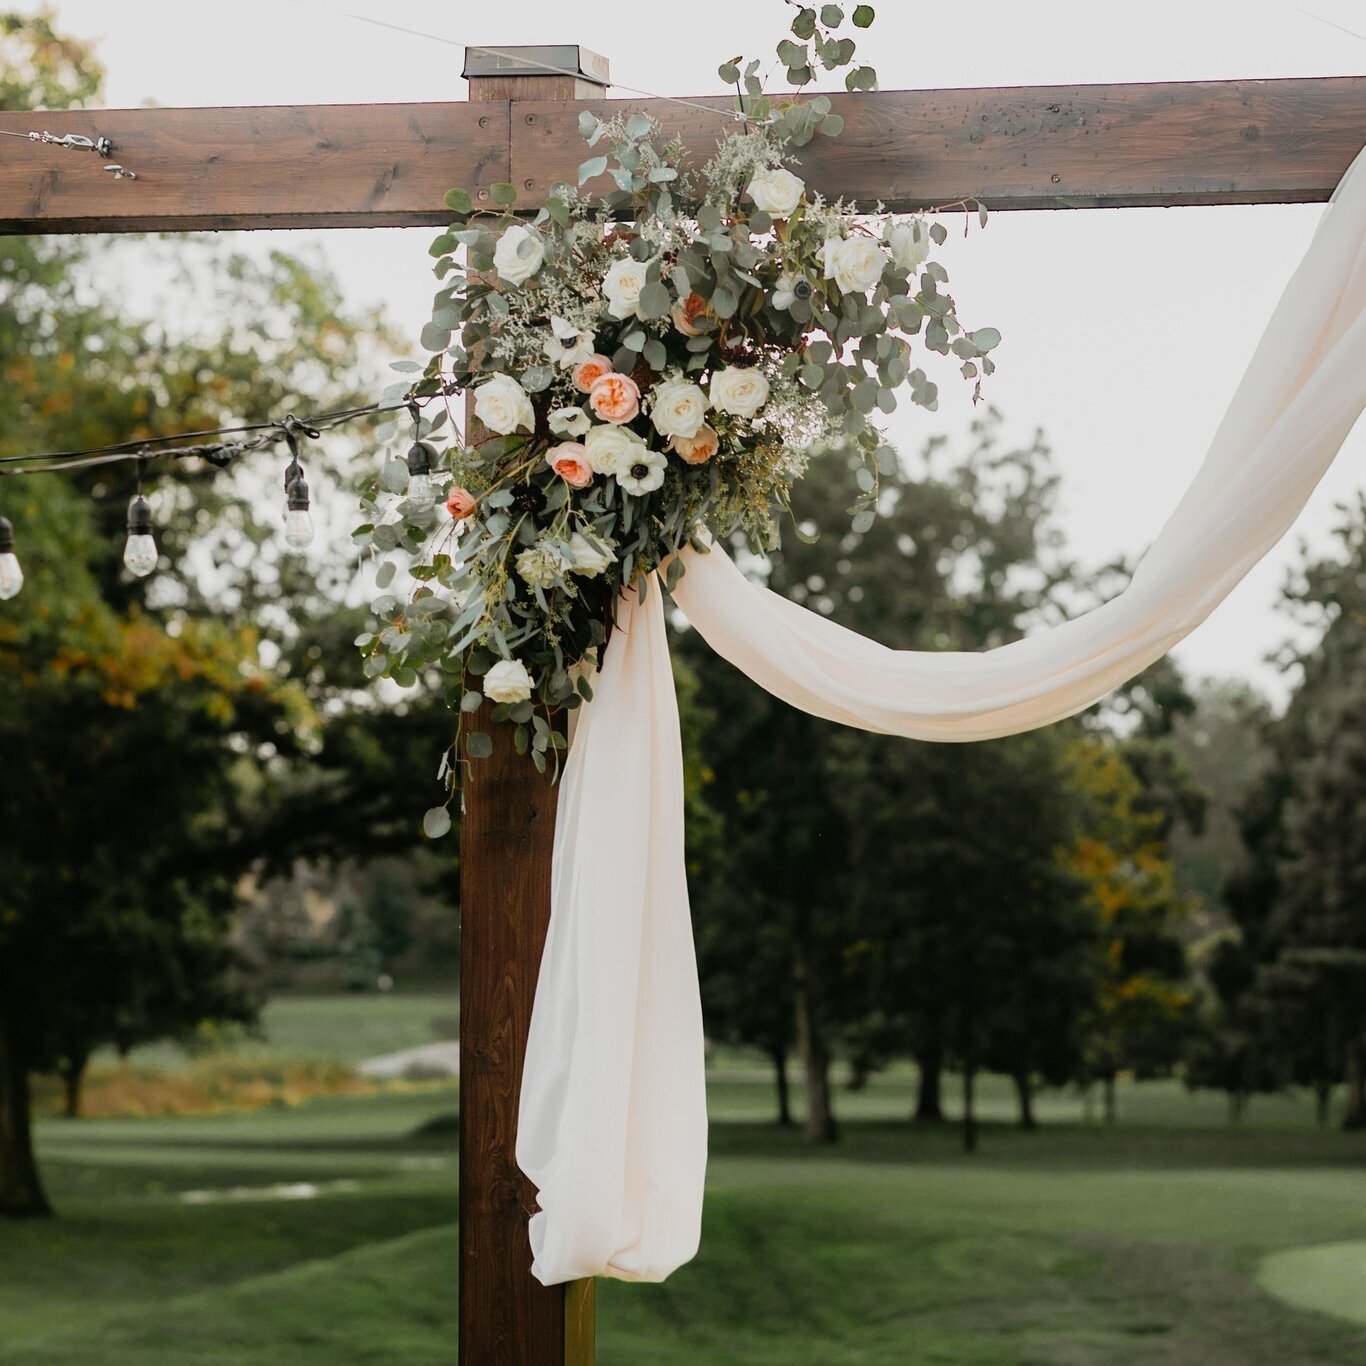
[1227,494,1366,1128]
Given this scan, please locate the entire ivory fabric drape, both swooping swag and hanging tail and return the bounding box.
[518,144,1366,1284]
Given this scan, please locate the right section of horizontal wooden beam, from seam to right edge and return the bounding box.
[512,76,1366,210]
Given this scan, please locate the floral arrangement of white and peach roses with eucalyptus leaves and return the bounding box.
[355,4,1000,833]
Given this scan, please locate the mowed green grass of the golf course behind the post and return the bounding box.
[0,1005,1366,1366]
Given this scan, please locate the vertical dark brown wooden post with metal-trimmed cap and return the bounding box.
[460,46,607,1366]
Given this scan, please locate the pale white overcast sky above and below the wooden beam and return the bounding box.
[19,0,1366,693]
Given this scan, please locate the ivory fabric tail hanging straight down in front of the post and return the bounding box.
[516,579,706,1285]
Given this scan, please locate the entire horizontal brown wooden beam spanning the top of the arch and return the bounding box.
[0,76,1366,234]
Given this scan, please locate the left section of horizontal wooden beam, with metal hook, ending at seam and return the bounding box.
[0,101,511,234]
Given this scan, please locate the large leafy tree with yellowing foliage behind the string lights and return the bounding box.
[0,15,449,1214]
